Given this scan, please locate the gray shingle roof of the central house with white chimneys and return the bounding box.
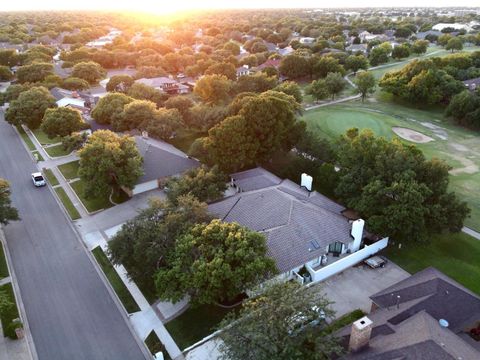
[209,168,352,272]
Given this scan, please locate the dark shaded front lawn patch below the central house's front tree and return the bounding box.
[165,305,239,350]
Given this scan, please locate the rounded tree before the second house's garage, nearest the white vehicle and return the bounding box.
[78,130,143,197]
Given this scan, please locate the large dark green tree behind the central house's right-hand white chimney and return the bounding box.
[336,129,469,241]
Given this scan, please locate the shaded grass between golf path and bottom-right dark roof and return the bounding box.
[386,233,480,295]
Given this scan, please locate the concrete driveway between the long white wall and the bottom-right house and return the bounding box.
[315,261,410,317]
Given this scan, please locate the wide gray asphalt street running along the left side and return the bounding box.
[0,113,145,360]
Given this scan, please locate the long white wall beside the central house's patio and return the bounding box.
[307,237,388,283]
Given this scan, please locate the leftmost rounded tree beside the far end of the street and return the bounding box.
[5,86,56,130]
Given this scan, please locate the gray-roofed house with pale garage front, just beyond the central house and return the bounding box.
[126,136,200,196]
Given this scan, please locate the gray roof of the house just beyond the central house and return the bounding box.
[135,136,199,184]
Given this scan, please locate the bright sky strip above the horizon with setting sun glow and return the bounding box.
[0,0,480,14]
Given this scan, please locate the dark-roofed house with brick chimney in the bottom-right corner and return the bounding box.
[337,268,480,360]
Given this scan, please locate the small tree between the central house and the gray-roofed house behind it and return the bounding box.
[166,166,227,204]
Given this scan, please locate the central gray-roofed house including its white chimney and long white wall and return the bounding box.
[209,168,388,284]
